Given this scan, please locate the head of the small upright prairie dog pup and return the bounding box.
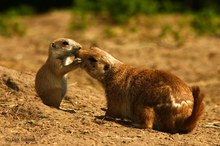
[49,38,82,60]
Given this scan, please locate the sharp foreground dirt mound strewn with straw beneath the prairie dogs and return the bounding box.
[0,67,220,145]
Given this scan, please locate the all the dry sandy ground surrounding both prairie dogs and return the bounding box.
[0,11,220,146]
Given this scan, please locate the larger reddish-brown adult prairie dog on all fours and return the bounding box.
[76,47,204,133]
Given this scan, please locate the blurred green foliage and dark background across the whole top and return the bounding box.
[0,0,220,36]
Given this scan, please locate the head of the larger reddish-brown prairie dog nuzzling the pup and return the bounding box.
[76,47,120,81]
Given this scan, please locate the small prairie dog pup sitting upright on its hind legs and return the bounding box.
[35,38,81,108]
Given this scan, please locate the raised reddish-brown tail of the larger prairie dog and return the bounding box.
[177,86,204,133]
